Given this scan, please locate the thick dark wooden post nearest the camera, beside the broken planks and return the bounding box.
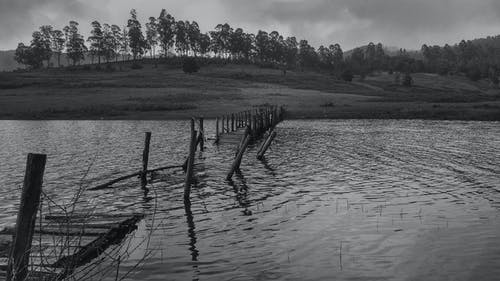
[7,153,47,281]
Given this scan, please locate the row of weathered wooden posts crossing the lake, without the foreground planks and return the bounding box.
[7,106,284,280]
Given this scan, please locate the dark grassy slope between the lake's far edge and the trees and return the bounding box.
[0,61,500,120]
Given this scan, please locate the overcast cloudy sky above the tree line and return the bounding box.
[0,0,500,50]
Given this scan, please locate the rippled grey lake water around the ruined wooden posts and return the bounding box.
[0,120,500,280]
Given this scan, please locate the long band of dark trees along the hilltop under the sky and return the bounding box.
[11,9,500,85]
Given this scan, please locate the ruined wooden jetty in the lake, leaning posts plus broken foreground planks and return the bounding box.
[0,106,284,281]
